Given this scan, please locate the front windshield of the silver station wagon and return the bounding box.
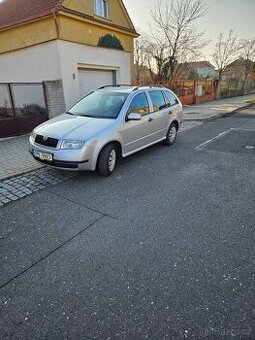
[68,91,128,119]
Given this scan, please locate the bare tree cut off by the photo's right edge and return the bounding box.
[239,38,255,81]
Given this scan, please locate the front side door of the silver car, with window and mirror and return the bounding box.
[121,92,153,156]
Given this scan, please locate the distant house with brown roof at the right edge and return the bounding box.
[223,58,255,81]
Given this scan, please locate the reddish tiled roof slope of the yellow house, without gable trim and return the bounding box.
[0,0,62,28]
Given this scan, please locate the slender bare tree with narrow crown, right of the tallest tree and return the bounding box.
[212,29,239,99]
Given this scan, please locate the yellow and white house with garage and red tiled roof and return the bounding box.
[0,0,138,116]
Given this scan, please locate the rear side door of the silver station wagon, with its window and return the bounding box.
[148,90,171,141]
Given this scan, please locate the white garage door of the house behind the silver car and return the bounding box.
[79,69,115,97]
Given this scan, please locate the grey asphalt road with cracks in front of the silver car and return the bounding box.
[0,108,255,340]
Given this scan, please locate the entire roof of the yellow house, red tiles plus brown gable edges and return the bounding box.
[0,0,138,36]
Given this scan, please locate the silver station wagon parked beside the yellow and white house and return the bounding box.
[29,85,182,176]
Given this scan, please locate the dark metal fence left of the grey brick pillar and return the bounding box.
[0,83,48,138]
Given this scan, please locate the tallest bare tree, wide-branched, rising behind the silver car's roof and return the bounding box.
[150,0,207,82]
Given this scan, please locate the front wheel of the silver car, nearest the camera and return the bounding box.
[98,144,117,177]
